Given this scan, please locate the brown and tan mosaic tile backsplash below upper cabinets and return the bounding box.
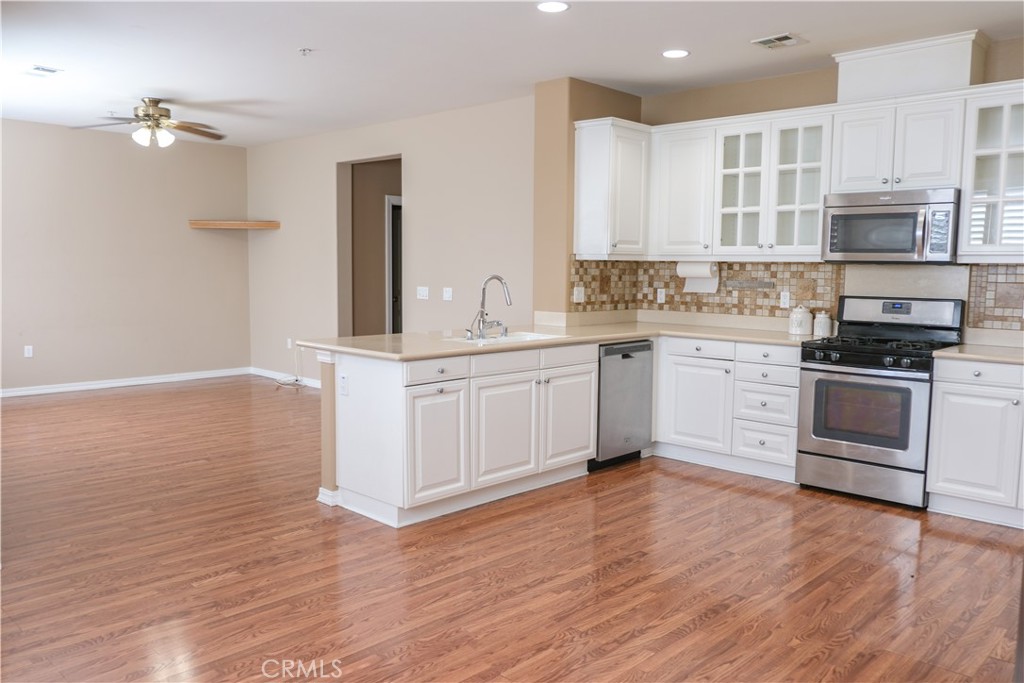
[568,261,1024,330]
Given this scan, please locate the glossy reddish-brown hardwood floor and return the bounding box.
[0,377,1024,682]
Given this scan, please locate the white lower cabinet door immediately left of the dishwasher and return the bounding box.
[540,364,597,469]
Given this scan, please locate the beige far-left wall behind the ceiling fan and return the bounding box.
[2,120,250,389]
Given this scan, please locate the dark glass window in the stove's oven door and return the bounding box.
[814,380,911,451]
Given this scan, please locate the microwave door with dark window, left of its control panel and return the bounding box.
[821,205,928,263]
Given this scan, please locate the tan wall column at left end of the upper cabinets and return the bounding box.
[534,78,640,312]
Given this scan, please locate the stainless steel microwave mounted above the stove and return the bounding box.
[821,187,959,264]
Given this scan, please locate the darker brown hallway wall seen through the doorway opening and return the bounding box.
[350,159,401,335]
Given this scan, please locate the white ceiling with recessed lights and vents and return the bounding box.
[0,0,1024,146]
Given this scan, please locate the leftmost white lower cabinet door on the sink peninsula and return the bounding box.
[406,380,470,505]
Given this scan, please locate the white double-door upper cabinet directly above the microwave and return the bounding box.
[830,98,964,193]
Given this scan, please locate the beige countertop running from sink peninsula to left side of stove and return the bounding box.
[297,323,811,360]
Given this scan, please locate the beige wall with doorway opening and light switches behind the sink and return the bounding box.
[249,97,534,376]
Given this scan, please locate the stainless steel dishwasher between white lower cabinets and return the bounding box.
[596,340,654,463]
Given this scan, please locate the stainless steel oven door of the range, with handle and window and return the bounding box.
[797,362,932,471]
